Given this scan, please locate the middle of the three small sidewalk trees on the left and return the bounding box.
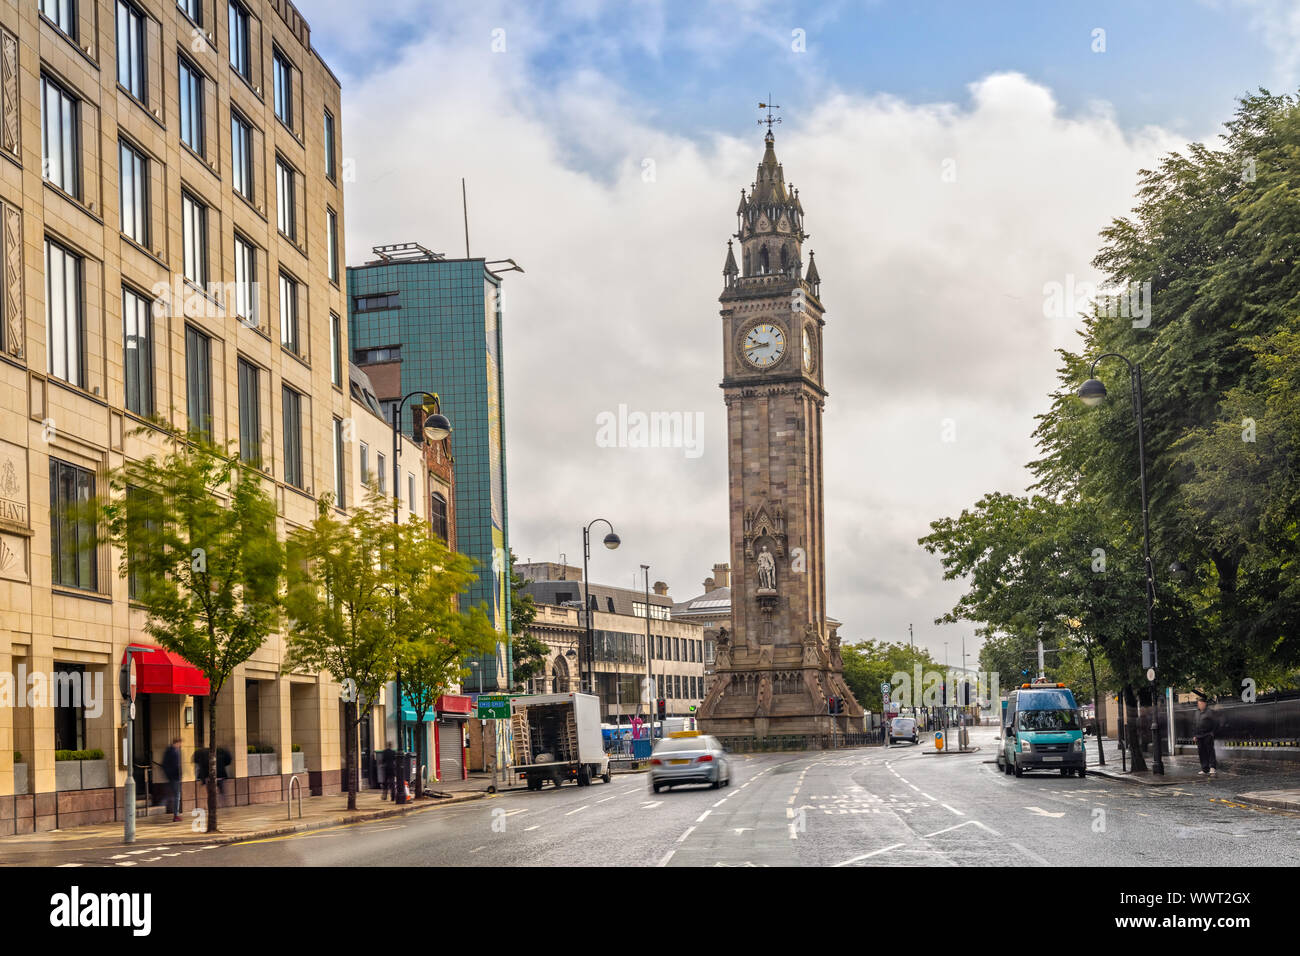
[283,488,402,810]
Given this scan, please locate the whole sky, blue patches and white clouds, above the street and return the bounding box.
[296,0,1300,663]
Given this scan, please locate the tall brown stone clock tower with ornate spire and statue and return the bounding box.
[699,127,863,737]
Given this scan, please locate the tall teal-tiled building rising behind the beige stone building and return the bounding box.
[347,246,511,693]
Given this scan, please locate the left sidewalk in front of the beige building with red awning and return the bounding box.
[0,773,491,865]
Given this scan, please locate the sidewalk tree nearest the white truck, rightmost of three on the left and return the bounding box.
[384,519,497,796]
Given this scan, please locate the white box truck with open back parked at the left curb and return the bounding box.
[510,693,610,790]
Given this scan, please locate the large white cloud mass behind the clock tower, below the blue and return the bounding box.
[343,13,1182,653]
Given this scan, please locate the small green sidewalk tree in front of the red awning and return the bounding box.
[99,429,285,832]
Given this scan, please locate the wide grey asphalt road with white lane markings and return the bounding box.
[48,728,1300,868]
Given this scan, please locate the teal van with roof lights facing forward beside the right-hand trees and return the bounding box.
[997,684,1087,777]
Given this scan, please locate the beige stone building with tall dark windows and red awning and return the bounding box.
[0,0,359,834]
